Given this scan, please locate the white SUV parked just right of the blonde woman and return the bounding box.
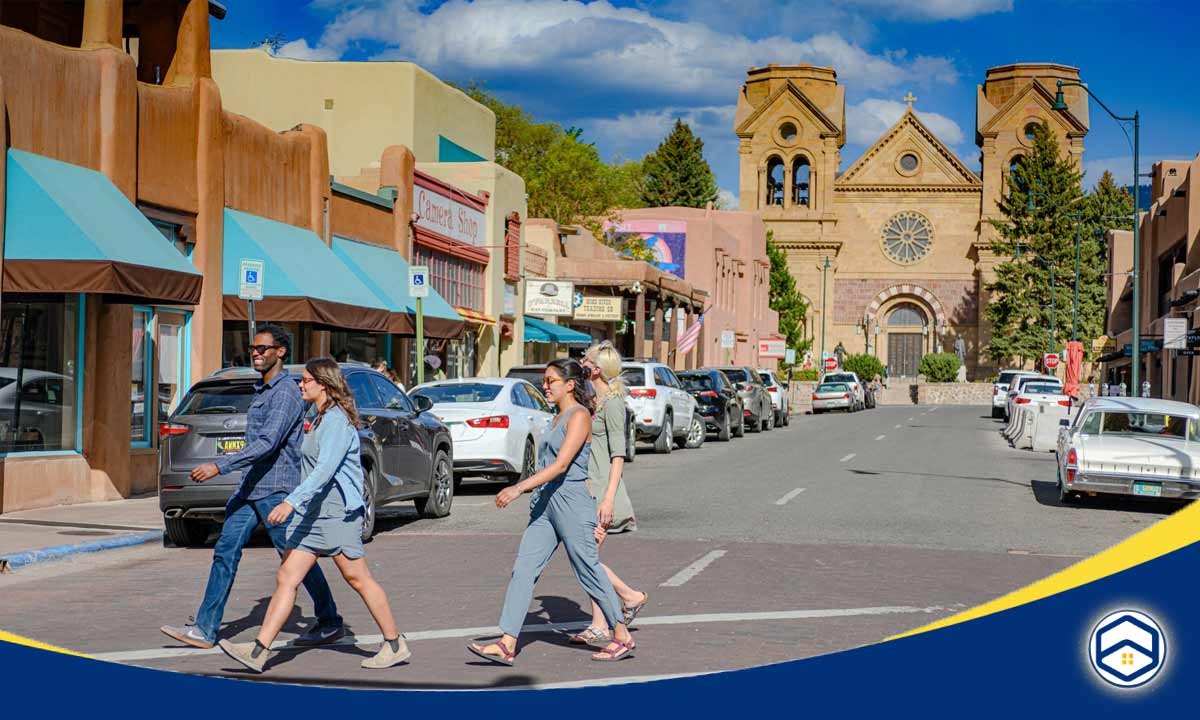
[620,361,704,452]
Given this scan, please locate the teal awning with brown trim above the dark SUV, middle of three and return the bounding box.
[222,208,390,332]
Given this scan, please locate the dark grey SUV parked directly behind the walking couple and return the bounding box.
[158,362,454,546]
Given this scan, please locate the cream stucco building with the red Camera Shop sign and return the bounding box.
[212,49,526,376]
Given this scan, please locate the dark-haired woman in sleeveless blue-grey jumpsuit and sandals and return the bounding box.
[467,358,634,666]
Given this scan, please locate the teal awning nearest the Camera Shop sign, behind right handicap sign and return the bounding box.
[334,235,463,338]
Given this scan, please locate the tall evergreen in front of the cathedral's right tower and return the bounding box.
[986,125,1104,361]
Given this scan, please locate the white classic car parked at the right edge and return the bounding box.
[1056,397,1200,503]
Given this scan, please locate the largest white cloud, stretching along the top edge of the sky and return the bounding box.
[304,0,958,104]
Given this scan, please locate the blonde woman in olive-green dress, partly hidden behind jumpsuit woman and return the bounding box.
[571,341,650,647]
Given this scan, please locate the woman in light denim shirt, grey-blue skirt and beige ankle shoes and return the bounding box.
[220,358,412,672]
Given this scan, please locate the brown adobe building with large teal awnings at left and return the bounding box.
[0,0,463,512]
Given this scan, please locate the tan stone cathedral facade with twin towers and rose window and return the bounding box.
[734,64,1088,379]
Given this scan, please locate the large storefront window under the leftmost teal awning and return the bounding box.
[0,294,83,452]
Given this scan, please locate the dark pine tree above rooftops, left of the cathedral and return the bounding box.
[642,120,718,208]
